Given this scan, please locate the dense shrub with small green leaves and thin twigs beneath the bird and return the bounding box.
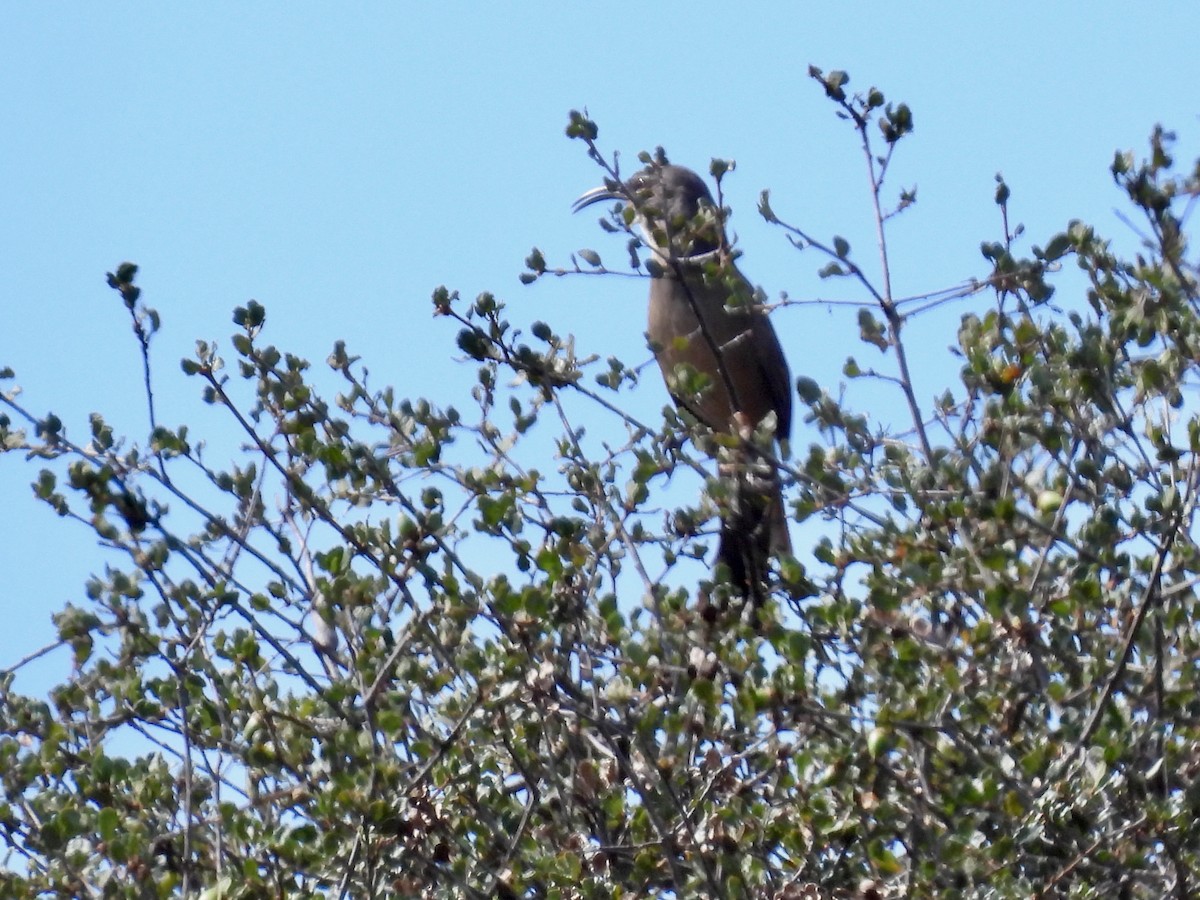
[0,70,1200,898]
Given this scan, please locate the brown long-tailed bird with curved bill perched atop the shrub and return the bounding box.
[572,161,792,607]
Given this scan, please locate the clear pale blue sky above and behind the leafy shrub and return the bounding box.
[0,0,1200,686]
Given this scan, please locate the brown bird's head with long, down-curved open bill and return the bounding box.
[571,163,725,259]
